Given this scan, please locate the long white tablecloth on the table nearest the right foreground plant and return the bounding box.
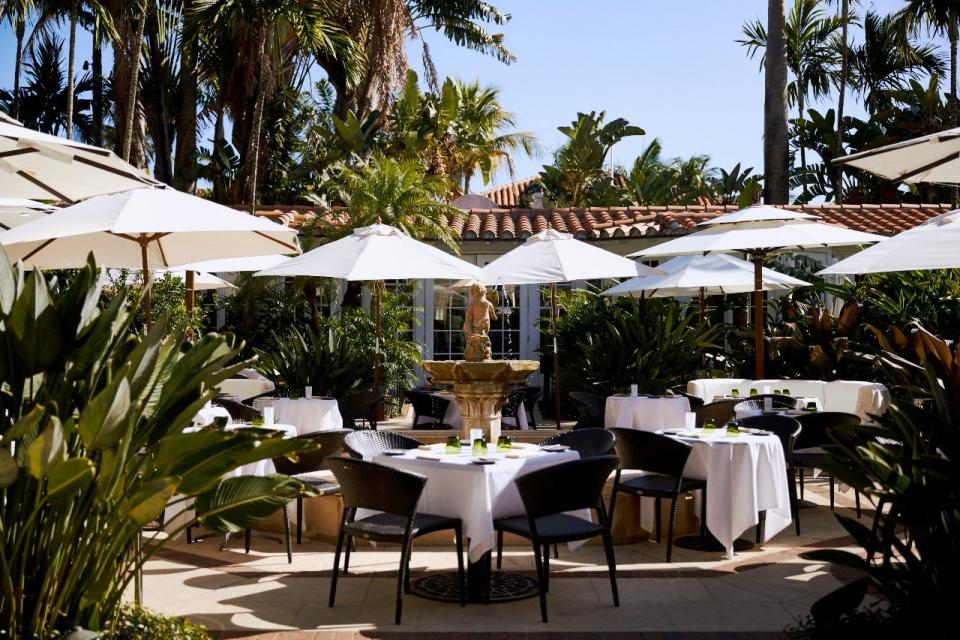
[684,433,791,556]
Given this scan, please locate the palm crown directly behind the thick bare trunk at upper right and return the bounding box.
[738,0,842,194]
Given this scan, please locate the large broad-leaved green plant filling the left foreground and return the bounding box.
[0,252,322,638]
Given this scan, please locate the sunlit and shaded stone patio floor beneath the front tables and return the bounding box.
[137,482,872,640]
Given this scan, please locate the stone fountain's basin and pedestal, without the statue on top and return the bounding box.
[423,360,540,443]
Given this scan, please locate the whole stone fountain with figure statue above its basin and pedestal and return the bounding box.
[423,284,540,443]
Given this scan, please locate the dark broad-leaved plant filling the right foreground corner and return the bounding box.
[802,324,960,637]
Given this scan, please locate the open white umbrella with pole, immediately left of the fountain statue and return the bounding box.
[255,223,480,391]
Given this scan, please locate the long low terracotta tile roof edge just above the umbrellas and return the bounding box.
[242,203,953,240]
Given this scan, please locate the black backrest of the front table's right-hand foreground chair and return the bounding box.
[516,456,617,518]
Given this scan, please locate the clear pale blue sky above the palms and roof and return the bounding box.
[0,0,924,190]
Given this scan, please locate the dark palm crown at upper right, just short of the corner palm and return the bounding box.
[850,11,946,114]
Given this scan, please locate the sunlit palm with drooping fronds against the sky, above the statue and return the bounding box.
[447,79,537,193]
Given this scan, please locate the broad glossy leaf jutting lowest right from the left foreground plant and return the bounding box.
[200,475,302,533]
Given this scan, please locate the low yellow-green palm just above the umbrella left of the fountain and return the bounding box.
[333,153,461,251]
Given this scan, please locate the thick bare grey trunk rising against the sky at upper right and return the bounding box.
[763,0,790,204]
